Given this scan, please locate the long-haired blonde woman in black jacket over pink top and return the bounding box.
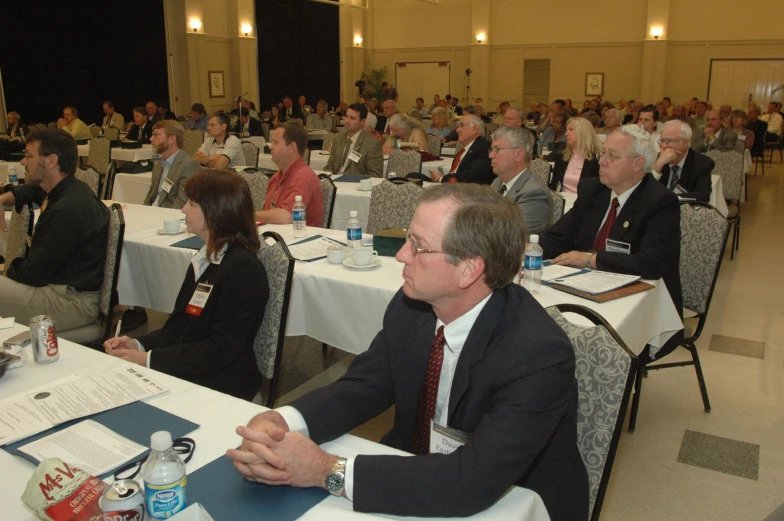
[550,118,602,194]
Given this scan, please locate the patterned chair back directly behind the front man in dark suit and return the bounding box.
[547,304,637,520]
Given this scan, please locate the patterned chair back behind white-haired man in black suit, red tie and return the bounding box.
[680,202,734,315]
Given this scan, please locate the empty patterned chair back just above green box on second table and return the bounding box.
[367,181,422,233]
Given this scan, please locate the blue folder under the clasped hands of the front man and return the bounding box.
[187,450,329,521]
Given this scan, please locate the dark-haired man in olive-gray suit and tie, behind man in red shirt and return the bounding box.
[324,103,384,177]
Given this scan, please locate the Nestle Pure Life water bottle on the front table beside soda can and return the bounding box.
[141,431,187,519]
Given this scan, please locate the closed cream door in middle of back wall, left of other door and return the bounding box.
[395,62,449,114]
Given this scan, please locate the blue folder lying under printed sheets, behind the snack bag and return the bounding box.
[3,402,199,479]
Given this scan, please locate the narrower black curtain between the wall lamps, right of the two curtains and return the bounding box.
[256,0,340,112]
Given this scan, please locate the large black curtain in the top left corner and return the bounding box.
[0,0,169,125]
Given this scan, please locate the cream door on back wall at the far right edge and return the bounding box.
[708,60,784,108]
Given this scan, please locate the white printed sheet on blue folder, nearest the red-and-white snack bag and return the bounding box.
[19,420,147,476]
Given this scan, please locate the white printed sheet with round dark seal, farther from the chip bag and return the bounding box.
[27,367,169,425]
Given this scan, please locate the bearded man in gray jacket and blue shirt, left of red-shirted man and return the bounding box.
[144,119,201,210]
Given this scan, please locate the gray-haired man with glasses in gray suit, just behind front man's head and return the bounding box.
[490,127,553,235]
